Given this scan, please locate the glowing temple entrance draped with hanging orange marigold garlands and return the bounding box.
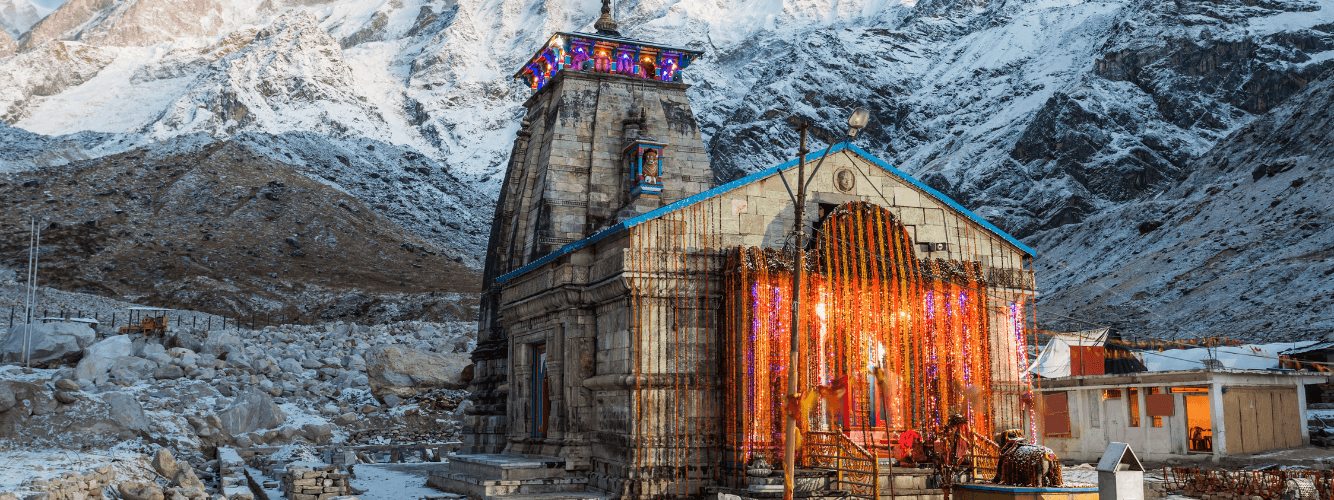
[723,203,1025,464]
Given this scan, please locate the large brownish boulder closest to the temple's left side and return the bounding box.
[366,345,472,399]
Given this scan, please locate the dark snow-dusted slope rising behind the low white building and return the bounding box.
[1030,62,1334,341]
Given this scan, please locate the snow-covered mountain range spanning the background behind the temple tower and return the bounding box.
[0,0,1334,333]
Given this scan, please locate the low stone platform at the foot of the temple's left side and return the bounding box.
[427,455,610,500]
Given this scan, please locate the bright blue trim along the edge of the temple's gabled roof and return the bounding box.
[496,143,1035,283]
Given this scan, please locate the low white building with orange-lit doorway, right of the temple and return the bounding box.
[1039,369,1330,460]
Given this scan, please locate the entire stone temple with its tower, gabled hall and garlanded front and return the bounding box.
[430,3,1042,499]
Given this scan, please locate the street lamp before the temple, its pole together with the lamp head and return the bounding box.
[779,108,879,500]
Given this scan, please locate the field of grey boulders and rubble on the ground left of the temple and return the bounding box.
[0,321,475,500]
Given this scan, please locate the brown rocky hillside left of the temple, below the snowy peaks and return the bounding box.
[0,137,478,323]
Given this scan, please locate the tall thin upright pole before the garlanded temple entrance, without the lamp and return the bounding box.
[783,123,810,500]
